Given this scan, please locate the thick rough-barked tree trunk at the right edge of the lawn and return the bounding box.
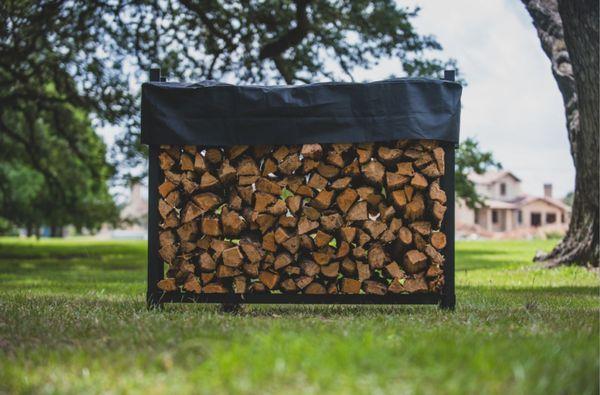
[523,0,600,267]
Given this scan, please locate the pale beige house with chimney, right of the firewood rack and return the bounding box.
[456,171,571,235]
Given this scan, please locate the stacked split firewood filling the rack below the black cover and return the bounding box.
[158,140,452,295]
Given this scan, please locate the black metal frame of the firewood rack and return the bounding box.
[142,69,456,310]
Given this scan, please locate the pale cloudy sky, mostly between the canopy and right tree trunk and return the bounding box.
[101,0,575,198]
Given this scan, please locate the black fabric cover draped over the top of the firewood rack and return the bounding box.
[142,78,462,146]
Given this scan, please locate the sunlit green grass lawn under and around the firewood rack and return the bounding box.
[0,239,600,394]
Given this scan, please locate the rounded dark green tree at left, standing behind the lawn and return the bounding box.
[0,105,118,236]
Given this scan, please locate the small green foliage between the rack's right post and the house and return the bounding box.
[454,137,502,208]
